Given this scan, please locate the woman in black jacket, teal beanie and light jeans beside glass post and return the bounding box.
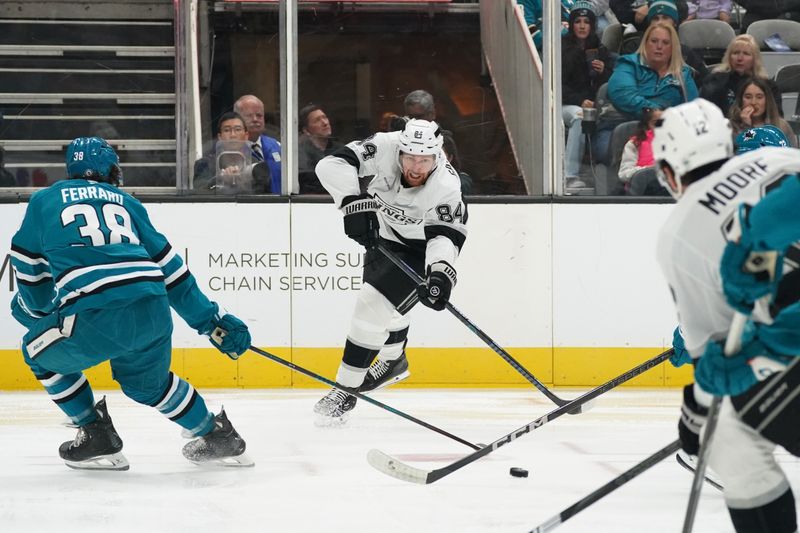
[561,0,613,187]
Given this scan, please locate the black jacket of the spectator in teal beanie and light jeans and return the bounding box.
[561,34,614,106]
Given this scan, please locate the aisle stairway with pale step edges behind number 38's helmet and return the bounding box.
[0,18,175,187]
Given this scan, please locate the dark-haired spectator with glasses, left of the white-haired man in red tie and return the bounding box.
[193,111,270,193]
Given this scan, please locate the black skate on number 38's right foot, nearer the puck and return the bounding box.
[183,409,255,466]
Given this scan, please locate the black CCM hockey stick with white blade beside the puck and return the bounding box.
[367,348,673,485]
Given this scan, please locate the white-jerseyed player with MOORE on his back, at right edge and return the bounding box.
[653,99,800,533]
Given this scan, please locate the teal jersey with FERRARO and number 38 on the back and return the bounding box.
[11,179,217,330]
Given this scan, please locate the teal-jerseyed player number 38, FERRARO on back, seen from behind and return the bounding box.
[11,137,253,470]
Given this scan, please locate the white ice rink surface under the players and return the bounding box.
[0,389,800,533]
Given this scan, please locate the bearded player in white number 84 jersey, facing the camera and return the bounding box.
[314,119,467,424]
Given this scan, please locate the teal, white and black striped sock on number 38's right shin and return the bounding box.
[149,372,214,436]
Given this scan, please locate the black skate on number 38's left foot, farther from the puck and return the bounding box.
[58,396,130,470]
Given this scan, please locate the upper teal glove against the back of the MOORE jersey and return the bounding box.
[720,204,783,314]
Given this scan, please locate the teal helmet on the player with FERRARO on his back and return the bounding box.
[66,137,122,186]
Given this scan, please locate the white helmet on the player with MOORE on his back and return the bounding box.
[653,98,733,198]
